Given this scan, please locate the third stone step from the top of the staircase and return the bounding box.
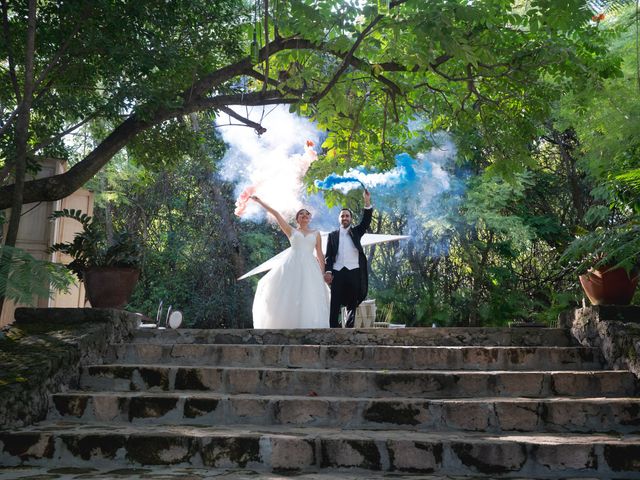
[80,365,640,398]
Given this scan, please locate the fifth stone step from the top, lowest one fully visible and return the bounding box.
[0,422,640,479]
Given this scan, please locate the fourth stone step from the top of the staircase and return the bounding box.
[48,392,640,433]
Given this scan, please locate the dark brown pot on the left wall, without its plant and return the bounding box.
[83,267,140,308]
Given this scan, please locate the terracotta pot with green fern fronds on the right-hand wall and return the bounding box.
[562,217,640,305]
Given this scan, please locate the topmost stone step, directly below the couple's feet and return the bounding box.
[131,327,577,347]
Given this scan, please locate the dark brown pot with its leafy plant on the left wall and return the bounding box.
[49,209,141,308]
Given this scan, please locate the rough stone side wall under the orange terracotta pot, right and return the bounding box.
[559,305,640,378]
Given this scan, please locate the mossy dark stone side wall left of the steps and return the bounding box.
[0,308,139,429]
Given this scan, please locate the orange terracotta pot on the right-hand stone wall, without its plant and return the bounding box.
[580,268,639,305]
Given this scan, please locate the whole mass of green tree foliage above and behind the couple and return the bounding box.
[0,0,640,326]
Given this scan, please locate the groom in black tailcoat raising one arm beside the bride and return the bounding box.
[324,189,373,328]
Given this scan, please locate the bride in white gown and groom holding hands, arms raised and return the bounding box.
[251,190,373,329]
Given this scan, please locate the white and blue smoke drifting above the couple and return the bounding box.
[218,107,465,248]
